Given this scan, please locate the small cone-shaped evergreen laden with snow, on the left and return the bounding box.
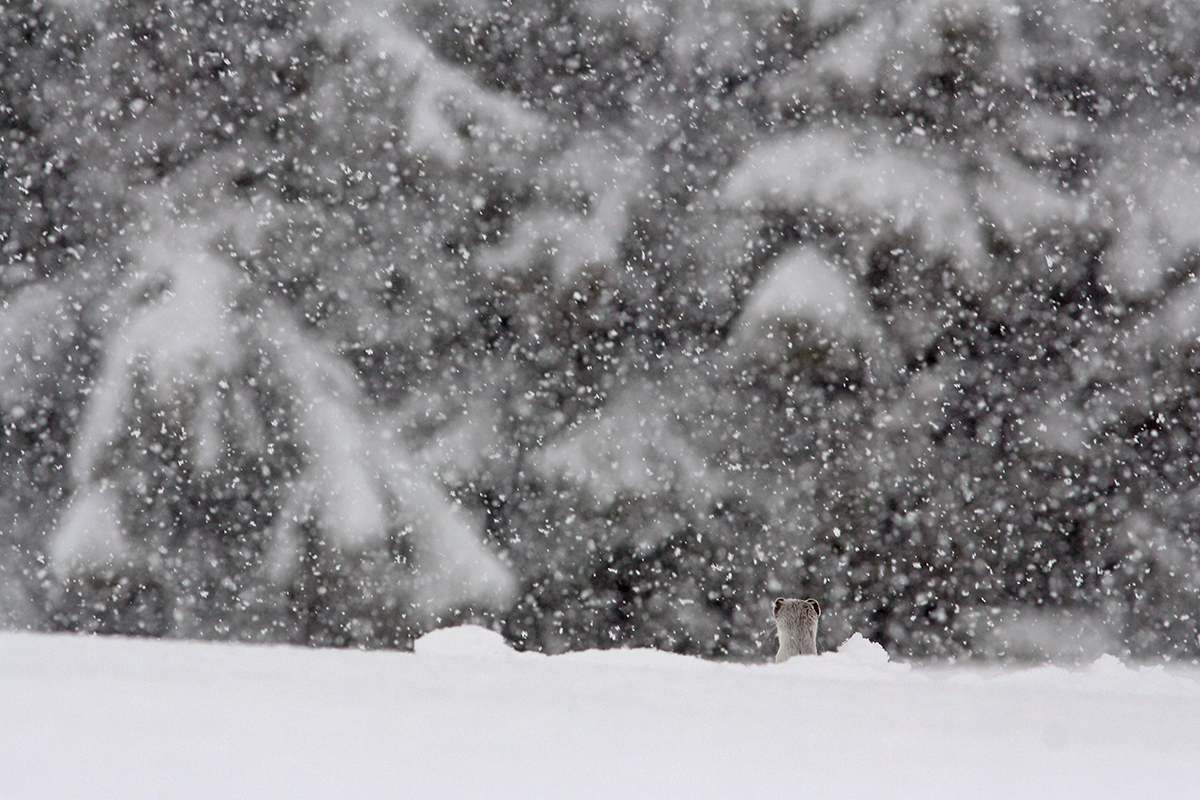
[48,210,511,640]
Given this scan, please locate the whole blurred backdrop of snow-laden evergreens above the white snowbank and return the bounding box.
[0,0,1200,661]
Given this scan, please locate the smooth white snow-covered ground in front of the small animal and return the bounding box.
[0,628,1200,800]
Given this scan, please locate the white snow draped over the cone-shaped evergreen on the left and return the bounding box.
[46,225,515,621]
